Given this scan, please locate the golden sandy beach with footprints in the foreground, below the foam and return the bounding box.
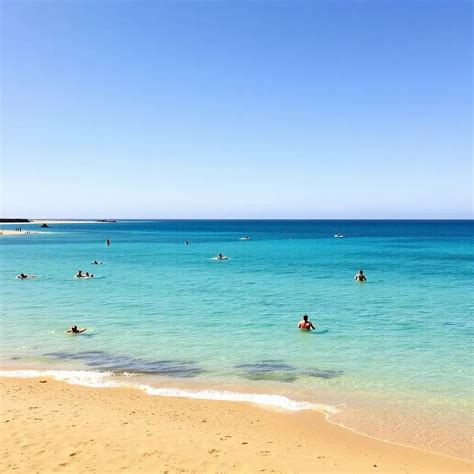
[0,378,472,473]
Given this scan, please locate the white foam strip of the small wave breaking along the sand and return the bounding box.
[0,370,338,413]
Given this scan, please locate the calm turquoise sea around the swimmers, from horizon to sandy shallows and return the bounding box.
[0,221,474,457]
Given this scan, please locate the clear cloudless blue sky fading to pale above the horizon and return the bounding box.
[0,0,473,219]
